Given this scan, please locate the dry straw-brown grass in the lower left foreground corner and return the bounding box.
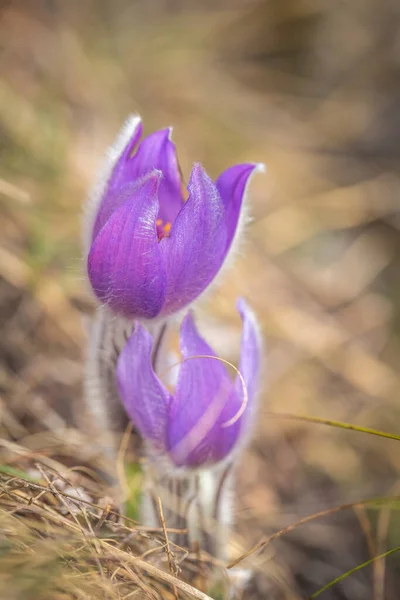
[0,444,222,600]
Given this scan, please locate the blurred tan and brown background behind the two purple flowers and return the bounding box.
[0,0,400,600]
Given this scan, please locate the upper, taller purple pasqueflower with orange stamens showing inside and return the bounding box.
[86,117,258,319]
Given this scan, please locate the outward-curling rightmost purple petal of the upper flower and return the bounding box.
[215,164,260,251]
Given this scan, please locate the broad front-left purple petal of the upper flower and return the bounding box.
[88,172,166,319]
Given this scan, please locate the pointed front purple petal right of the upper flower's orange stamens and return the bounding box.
[160,164,227,314]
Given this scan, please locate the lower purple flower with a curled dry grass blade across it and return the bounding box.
[117,299,261,467]
